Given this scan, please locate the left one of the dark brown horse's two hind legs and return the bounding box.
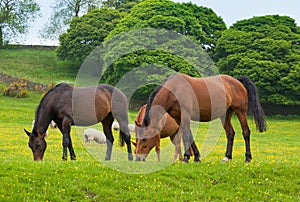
[102,113,114,161]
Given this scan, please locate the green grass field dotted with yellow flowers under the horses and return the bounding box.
[0,50,300,201]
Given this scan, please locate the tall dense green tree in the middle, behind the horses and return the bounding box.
[102,0,226,97]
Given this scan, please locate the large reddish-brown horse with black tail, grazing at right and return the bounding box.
[136,74,266,162]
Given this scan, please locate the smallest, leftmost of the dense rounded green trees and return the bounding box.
[57,7,124,62]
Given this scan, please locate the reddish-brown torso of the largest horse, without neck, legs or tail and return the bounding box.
[171,74,248,121]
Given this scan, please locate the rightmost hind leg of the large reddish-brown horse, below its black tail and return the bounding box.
[236,112,252,163]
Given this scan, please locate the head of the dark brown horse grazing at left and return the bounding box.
[24,129,47,161]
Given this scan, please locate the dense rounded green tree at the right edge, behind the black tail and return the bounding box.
[214,15,300,104]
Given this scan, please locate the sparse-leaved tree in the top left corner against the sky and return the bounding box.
[0,0,40,48]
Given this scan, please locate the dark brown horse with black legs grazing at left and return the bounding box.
[24,83,133,160]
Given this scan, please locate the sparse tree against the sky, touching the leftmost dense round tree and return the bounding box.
[40,0,101,39]
